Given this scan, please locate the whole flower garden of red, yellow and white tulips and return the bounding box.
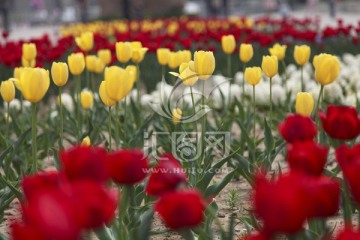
[0,17,360,240]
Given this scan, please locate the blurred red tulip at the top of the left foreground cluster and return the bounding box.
[60,146,109,182]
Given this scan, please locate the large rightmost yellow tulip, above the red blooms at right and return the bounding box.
[313,54,340,85]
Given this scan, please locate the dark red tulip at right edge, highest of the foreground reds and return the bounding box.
[319,105,360,140]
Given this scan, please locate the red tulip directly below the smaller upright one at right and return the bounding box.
[286,140,329,176]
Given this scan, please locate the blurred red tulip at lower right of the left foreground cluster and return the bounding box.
[71,181,118,229]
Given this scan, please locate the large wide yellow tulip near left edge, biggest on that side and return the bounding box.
[19,68,50,103]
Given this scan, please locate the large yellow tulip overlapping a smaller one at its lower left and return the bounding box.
[105,66,134,101]
